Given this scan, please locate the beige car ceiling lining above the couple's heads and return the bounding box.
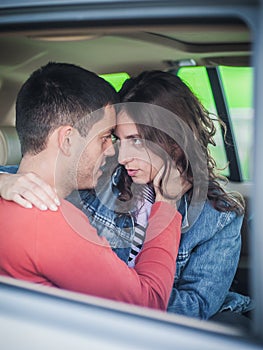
[0,18,251,125]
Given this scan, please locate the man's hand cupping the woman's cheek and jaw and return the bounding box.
[153,164,192,205]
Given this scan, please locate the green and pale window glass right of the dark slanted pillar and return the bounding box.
[219,67,254,180]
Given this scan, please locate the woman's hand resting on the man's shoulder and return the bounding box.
[0,173,60,211]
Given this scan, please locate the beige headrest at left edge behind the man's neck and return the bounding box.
[0,126,22,165]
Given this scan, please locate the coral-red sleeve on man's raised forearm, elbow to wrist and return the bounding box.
[135,202,181,310]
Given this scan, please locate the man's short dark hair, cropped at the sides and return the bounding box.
[16,62,118,154]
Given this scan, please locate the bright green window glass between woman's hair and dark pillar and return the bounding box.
[178,67,229,176]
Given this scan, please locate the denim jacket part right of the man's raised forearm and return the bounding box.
[168,200,251,319]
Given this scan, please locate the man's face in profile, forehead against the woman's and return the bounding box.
[73,105,116,189]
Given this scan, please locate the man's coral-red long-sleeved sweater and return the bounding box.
[0,198,181,310]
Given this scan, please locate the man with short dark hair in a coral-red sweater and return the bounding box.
[0,63,181,310]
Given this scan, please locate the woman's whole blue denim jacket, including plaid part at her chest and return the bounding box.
[0,167,252,319]
